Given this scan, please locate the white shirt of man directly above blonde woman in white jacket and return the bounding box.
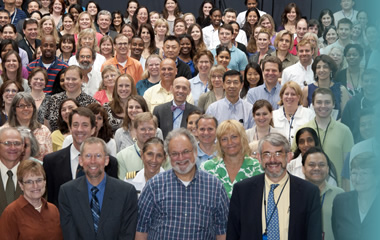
[281,61,314,89]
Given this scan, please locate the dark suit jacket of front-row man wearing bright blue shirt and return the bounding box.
[59,176,137,240]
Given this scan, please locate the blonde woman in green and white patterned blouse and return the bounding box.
[200,120,263,198]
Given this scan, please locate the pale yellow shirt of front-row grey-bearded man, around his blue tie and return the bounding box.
[261,172,290,240]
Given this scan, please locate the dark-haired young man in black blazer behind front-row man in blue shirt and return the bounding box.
[43,107,118,206]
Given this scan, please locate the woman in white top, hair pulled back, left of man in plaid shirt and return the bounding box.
[124,137,166,193]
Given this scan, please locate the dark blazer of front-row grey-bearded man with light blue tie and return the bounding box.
[227,174,322,240]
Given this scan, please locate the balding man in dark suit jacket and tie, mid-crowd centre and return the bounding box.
[153,77,200,139]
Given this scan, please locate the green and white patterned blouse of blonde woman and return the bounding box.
[200,156,264,198]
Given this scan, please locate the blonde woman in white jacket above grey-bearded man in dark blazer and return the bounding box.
[273,81,314,143]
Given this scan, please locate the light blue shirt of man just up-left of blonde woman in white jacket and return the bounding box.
[247,83,281,110]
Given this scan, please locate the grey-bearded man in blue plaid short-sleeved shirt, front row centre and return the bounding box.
[135,128,228,240]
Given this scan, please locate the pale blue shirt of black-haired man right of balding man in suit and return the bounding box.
[206,98,255,129]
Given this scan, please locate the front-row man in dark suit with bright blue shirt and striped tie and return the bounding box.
[59,137,137,240]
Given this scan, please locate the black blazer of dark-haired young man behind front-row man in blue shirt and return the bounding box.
[43,144,118,207]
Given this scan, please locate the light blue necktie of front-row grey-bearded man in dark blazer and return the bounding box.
[267,184,280,240]
